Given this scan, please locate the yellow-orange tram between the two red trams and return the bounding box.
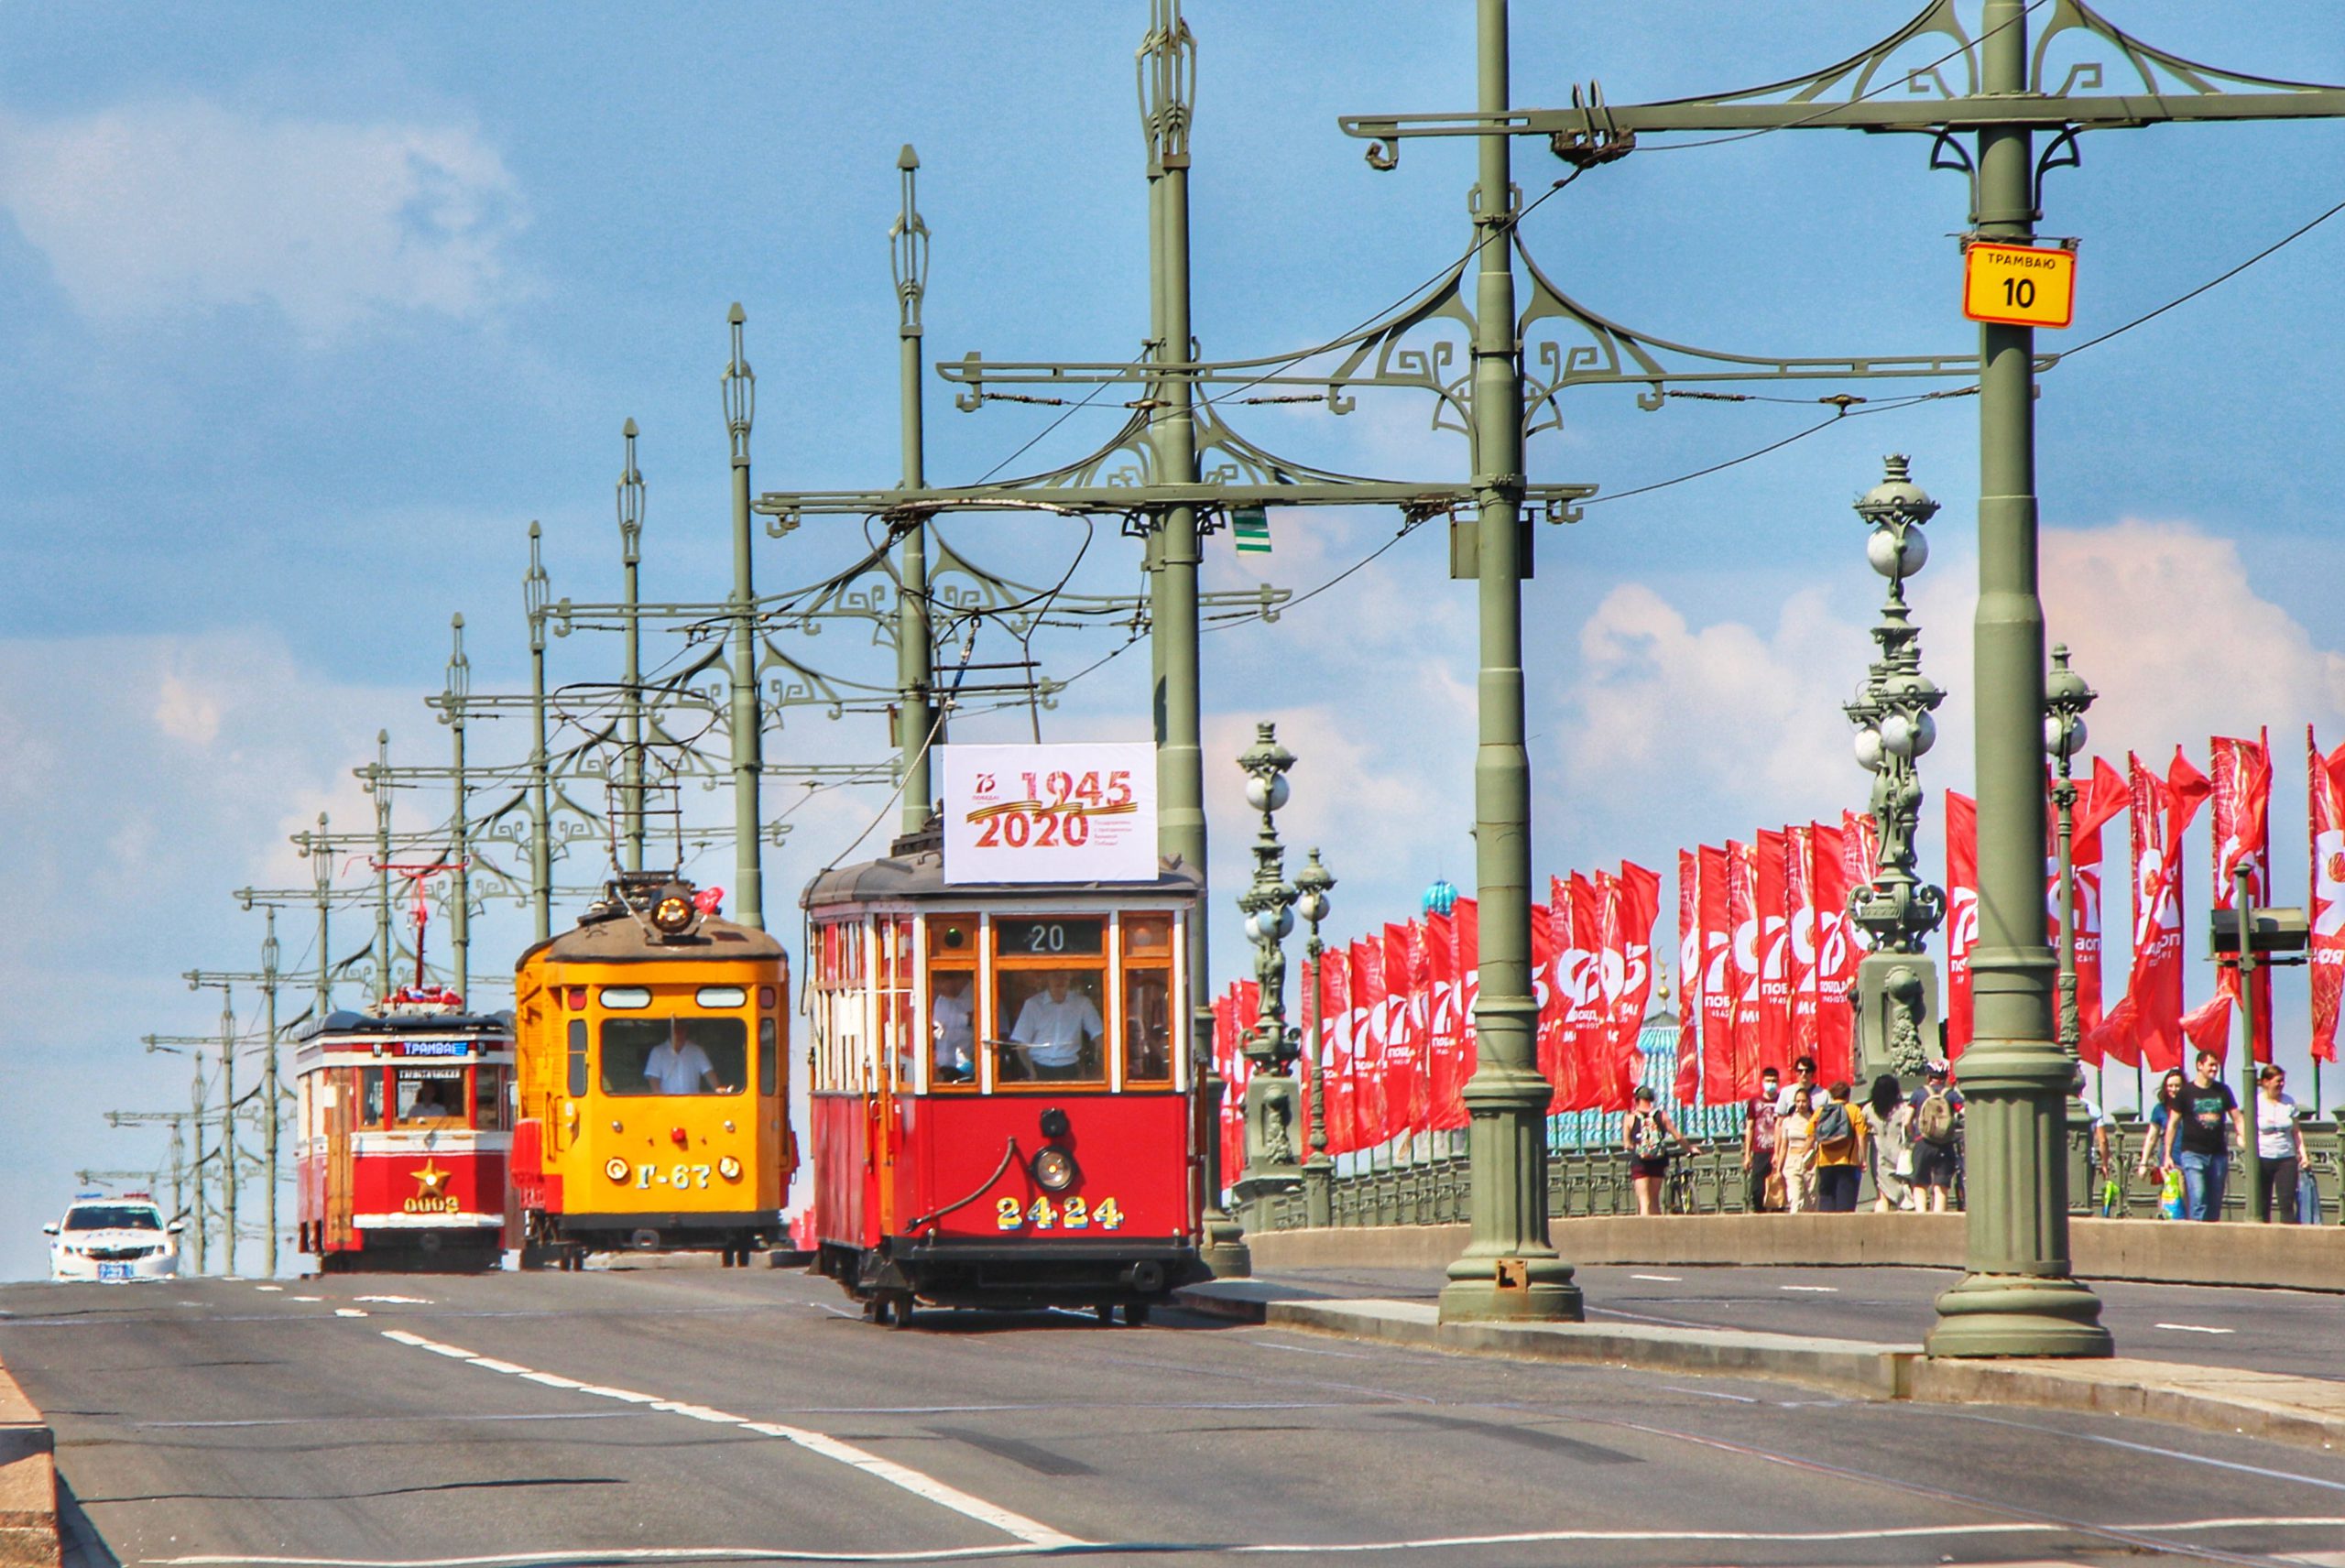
[507,872,797,1268]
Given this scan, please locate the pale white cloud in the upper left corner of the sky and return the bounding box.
[0,98,525,340]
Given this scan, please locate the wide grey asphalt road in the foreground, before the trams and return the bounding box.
[0,1268,2345,1568]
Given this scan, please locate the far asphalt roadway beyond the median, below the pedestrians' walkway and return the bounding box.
[1273,1263,2345,1380]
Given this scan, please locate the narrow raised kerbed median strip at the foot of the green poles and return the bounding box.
[1177,1279,2345,1451]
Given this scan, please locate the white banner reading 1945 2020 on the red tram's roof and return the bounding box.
[938,741,1156,884]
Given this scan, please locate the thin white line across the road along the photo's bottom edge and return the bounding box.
[141,1517,2345,1568]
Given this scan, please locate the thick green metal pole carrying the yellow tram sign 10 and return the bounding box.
[1927,0,2110,1357]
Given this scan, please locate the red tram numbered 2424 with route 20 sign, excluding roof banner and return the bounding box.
[804,846,1205,1324]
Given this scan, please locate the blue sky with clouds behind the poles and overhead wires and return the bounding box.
[0,0,2345,1275]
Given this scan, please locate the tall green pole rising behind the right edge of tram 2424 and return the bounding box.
[1142,0,1252,1278]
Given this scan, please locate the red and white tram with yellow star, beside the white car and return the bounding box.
[293,986,514,1273]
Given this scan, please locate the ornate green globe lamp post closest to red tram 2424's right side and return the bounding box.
[1234,724,1302,1204]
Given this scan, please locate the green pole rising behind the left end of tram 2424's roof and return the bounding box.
[889,143,943,834]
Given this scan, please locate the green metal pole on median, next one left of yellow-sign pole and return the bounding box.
[1440,0,1580,1322]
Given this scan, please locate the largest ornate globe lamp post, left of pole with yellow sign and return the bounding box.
[1843,457,1947,1085]
